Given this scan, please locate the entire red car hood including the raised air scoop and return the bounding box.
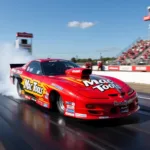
[50,69,129,99]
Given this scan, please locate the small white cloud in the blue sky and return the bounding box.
[68,21,95,29]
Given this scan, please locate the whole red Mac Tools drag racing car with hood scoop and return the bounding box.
[10,58,139,120]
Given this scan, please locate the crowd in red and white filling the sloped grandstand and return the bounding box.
[117,40,150,65]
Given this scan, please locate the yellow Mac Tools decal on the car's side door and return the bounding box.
[22,79,45,96]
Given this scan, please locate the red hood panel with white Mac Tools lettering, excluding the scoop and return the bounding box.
[79,75,126,99]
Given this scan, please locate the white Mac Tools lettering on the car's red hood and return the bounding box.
[83,79,121,92]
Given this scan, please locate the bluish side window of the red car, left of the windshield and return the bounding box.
[27,62,42,75]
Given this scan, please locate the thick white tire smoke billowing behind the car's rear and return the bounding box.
[0,43,34,98]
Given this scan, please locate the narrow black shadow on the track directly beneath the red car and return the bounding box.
[4,97,150,128]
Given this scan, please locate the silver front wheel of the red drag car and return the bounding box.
[56,95,65,115]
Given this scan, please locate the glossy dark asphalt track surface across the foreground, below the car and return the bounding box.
[0,93,150,150]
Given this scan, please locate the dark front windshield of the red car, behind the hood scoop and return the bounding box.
[41,61,80,76]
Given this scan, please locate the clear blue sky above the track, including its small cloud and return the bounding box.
[0,0,150,59]
